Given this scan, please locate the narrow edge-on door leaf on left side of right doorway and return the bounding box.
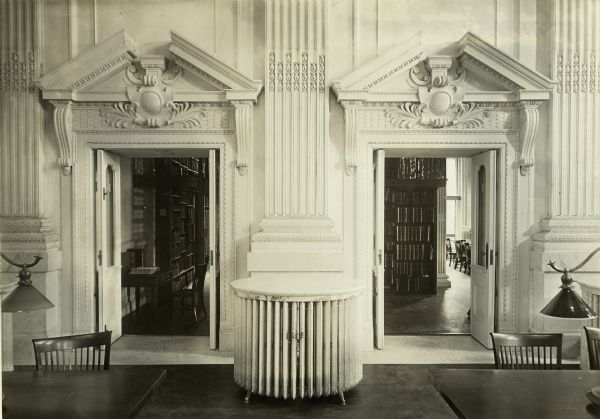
[373,150,385,349]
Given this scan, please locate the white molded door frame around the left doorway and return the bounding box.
[72,130,239,350]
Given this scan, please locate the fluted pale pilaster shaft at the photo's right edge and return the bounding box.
[550,0,600,218]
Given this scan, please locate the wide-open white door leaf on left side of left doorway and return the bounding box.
[96,150,121,341]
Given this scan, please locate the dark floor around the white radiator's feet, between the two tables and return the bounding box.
[132,365,492,419]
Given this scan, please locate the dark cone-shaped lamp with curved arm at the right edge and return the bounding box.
[540,247,600,319]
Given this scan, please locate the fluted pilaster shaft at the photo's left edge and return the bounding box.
[0,0,44,217]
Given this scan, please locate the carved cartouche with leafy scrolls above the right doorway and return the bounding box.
[385,56,487,128]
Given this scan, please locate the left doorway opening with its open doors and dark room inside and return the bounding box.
[96,149,220,349]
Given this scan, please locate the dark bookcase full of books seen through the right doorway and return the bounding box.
[384,158,446,294]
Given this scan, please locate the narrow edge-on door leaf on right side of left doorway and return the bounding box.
[208,150,219,349]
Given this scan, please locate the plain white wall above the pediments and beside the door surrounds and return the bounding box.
[31,0,568,354]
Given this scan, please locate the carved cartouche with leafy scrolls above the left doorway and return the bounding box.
[100,56,205,128]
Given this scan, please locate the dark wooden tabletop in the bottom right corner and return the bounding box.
[429,369,600,419]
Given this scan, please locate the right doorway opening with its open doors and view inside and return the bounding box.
[374,150,498,352]
